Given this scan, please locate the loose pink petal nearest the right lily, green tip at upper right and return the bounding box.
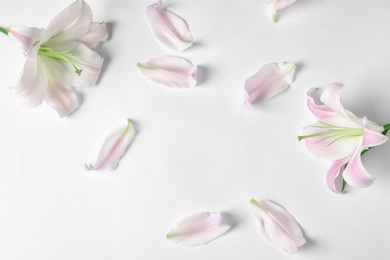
[244,63,295,108]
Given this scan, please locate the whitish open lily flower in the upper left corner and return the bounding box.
[8,0,108,117]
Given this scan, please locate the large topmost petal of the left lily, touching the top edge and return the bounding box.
[40,0,92,44]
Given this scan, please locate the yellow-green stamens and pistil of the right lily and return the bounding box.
[298,122,363,145]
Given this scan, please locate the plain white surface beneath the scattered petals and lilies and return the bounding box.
[0,0,390,260]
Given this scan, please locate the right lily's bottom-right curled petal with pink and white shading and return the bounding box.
[343,148,374,188]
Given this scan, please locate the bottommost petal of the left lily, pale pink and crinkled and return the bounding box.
[45,77,79,118]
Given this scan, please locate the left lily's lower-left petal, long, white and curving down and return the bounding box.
[10,50,46,108]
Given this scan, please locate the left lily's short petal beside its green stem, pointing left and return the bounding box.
[8,26,42,53]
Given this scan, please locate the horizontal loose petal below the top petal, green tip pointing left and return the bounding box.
[137,56,197,88]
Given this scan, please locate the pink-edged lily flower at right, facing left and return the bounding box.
[298,83,388,193]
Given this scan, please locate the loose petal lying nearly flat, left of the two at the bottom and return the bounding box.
[166,212,230,247]
